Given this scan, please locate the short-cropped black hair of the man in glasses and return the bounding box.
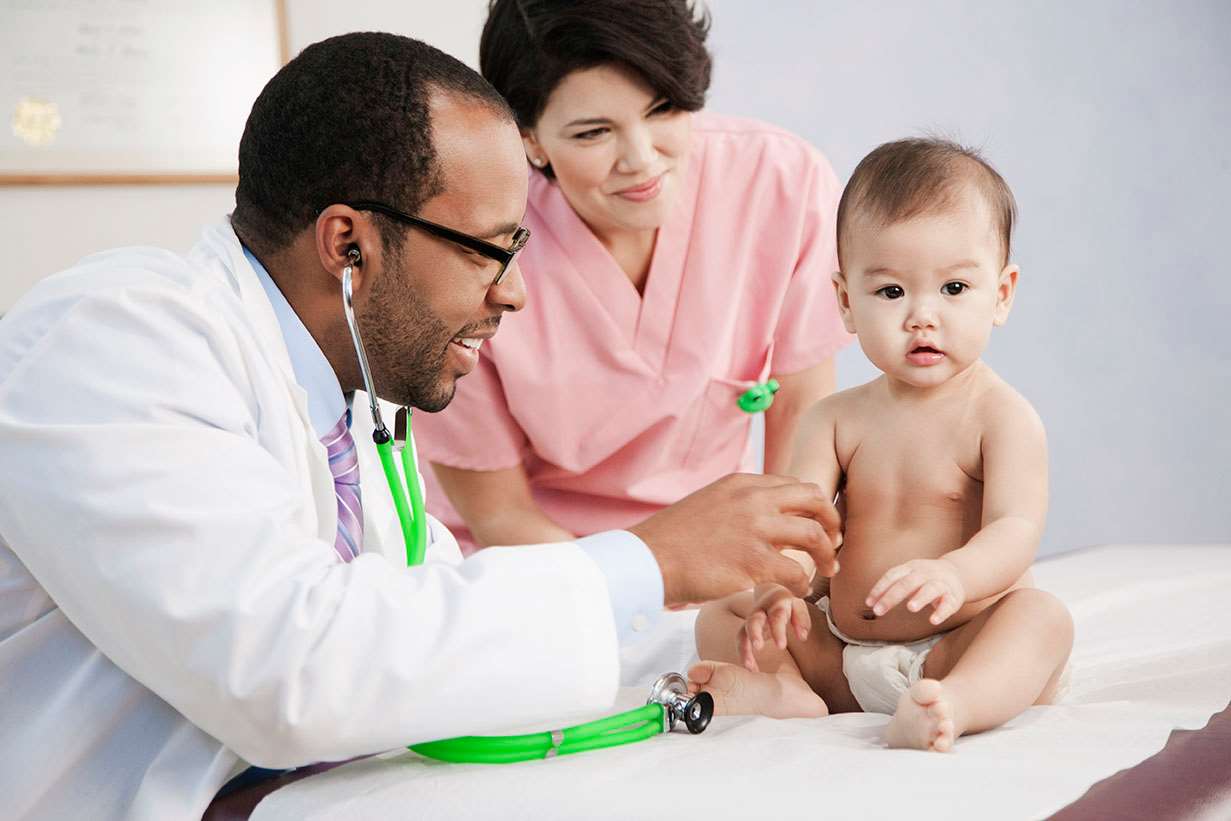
[231,32,513,256]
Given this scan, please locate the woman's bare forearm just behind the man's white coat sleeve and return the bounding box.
[432,462,576,547]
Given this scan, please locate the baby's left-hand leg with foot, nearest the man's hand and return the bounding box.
[688,592,859,719]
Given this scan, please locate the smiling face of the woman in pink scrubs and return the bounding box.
[523,65,692,236]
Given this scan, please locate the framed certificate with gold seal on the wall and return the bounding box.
[0,0,287,185]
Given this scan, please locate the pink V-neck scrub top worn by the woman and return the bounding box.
[414,114,852,551]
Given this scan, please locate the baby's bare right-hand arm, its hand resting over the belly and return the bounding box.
[865,389,1048,624]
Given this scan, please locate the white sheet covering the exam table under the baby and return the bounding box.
[252,544,1231,821]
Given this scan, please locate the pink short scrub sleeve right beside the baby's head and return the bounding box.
[771,148,853,374]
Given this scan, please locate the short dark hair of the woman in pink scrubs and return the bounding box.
[479,0,712,139]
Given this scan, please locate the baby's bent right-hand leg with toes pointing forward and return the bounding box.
[886,588,1073,751]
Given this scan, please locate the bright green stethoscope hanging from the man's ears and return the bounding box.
[342,254,718,764]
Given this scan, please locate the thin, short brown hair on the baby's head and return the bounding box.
[837,138,1017,267]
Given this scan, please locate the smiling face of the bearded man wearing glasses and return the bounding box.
[359,94,526,412]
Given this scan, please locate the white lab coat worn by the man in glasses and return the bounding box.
[0,224,618,821]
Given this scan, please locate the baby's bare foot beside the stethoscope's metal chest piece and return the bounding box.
[688,661,830,719]
